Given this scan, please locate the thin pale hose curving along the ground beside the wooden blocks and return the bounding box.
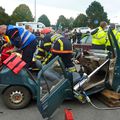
[83,91,120,110]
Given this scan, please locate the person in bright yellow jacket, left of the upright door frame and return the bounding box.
[91,21,107,50]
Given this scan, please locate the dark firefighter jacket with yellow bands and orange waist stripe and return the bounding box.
[35,34,73,59]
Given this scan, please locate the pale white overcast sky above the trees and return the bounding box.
[0,0,120,24]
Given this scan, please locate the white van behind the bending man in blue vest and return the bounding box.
[16,22,45,31]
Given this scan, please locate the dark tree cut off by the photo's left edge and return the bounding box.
[0,7,10,25]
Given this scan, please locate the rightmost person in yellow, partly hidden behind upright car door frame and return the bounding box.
[106,23,120,51]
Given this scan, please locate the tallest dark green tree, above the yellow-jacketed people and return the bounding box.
[86,1,109,28]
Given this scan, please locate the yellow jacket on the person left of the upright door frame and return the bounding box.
[92,27,107,45]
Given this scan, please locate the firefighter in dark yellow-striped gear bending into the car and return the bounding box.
[35,33,76,72]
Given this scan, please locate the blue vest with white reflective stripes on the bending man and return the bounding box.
[6,25,36,49]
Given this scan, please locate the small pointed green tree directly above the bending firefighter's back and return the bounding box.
[56,15,69,30]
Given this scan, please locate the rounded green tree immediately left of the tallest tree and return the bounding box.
[73,14,88,27]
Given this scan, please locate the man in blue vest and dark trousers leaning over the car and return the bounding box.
[0,25,37,68]
